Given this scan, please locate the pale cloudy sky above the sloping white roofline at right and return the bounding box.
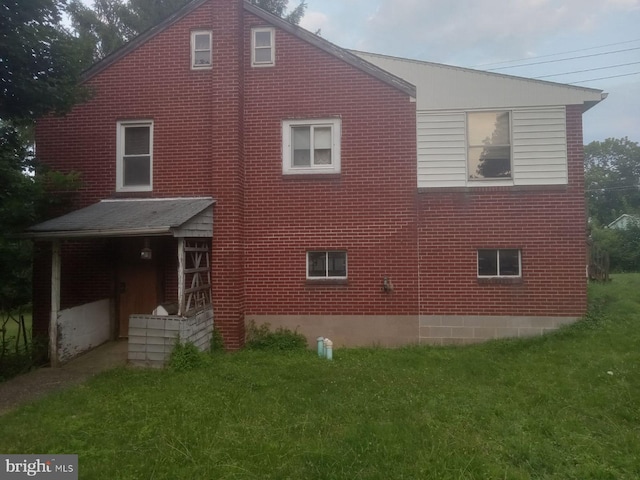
[298,0,640,144]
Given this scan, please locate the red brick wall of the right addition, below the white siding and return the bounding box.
[419,106,586,316]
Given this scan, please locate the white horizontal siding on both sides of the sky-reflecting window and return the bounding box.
[417,107,568,188]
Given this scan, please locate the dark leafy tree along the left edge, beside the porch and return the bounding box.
[0,0,86,312]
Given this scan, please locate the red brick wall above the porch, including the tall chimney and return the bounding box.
[35,0,244,347]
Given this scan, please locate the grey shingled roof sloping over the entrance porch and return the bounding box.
[25,197,215,239]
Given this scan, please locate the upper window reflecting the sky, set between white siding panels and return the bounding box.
[467,112,511,180]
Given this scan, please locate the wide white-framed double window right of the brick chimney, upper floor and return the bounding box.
[282,118,340,174]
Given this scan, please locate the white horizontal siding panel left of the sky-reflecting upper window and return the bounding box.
[417,112,467,187]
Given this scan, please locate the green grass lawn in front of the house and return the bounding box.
[0,274,640,480]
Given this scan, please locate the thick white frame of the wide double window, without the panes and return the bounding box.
[282,118,342,175]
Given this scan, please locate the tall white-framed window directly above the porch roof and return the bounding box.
[116,120,153,192]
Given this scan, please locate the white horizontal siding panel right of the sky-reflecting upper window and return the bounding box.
[512,107,568,185]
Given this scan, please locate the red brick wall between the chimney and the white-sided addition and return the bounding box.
[242,15,417,315]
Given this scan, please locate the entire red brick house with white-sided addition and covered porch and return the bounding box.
[29,0,603,364]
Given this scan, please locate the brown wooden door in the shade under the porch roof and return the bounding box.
[118,260,158,338]
